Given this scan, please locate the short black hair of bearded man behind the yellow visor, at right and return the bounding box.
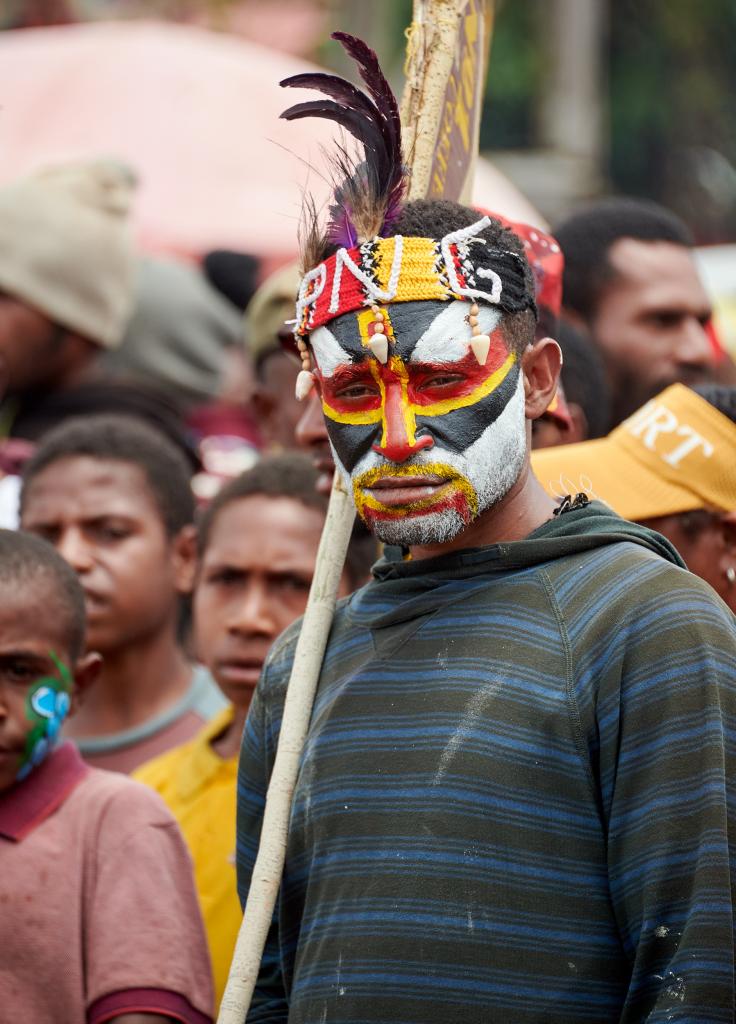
[553,197,693,322]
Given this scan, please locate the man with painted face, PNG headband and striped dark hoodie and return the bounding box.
[237,32,736,1024]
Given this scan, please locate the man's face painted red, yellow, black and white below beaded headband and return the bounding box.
[310,301,526,546]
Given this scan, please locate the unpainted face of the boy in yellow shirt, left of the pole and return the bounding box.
[193,495,337,708]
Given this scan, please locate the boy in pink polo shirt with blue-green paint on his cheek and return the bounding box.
[0,530,213,1024]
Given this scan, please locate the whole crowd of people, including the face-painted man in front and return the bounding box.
[0,54,736,1024]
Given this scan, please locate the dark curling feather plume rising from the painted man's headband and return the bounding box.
[279,32,407,270]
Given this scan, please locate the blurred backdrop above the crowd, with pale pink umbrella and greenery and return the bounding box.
[0,0,736,348]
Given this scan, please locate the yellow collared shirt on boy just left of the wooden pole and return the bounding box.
[133,708,243,1007]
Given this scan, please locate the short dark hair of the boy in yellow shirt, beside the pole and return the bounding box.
[197,452,377,586]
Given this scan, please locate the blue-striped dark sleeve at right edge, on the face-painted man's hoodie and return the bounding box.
[578,569,736,1024]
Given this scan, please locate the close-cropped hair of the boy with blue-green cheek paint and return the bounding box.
[0,529,86,662]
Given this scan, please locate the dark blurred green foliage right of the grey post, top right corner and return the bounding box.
[609,0,736,240]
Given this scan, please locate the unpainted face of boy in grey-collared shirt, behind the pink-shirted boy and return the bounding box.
[21,456,190,653]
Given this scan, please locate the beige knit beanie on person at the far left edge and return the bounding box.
[0,160,135,348]
